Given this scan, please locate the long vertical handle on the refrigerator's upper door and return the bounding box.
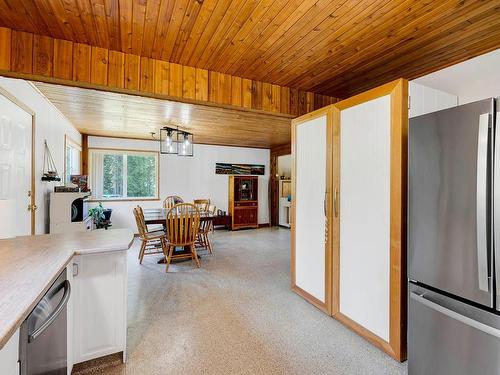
[476,113,490,292]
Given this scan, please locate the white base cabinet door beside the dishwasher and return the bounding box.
[73,251,127,363]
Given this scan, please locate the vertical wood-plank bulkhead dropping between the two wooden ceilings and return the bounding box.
[0,28,338,117]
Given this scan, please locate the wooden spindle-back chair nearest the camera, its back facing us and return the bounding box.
[165,203,200,272]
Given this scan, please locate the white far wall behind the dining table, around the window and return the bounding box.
[89,137,270,232]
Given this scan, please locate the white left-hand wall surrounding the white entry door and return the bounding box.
[0,77,81,234]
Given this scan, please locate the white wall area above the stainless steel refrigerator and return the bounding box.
[413,49,500,105]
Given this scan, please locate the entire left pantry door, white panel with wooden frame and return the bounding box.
[291,106,332,314]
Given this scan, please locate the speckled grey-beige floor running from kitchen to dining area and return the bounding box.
[79,228,407,375]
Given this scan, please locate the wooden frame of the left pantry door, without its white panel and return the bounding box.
[290,105,333,315]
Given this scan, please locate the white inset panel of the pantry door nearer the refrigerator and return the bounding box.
[339,95,391,341]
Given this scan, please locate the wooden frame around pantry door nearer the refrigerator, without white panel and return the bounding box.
[331,79,408,361]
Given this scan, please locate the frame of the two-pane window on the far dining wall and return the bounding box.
[87,147,160,202]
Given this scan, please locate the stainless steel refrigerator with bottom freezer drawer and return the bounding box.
[408,99,500,375]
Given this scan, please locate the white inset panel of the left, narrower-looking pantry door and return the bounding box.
[293,114,327,303]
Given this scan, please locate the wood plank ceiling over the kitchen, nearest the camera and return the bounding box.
[0,0,500,97]
